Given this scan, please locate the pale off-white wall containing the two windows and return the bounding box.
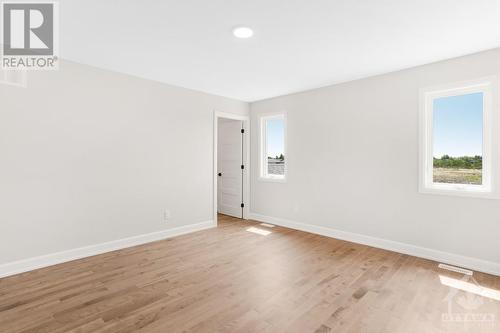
[251,49,500,273]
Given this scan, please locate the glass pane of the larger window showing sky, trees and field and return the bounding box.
[433,93,483,185]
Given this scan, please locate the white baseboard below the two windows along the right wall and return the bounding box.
[249,213,500,276]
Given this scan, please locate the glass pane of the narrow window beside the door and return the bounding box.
[266,118,285,176]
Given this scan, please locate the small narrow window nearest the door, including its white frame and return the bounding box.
[260,114,286,181]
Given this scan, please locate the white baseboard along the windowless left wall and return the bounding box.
[0,221,216,278]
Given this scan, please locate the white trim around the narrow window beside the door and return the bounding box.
[259,112,288,183]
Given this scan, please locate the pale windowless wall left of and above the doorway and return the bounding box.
[0,62,248,264]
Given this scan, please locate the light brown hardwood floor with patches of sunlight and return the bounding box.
[0,216,500,333]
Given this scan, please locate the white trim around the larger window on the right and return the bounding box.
[419,80,493,198]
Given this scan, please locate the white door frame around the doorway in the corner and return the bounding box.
[213,110,251,225]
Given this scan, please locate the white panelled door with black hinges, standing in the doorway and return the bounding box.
[217,118,243,217]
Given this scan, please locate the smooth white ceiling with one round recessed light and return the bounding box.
[59,0,500,101]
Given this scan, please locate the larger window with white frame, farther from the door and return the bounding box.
[421,83,491,193]
